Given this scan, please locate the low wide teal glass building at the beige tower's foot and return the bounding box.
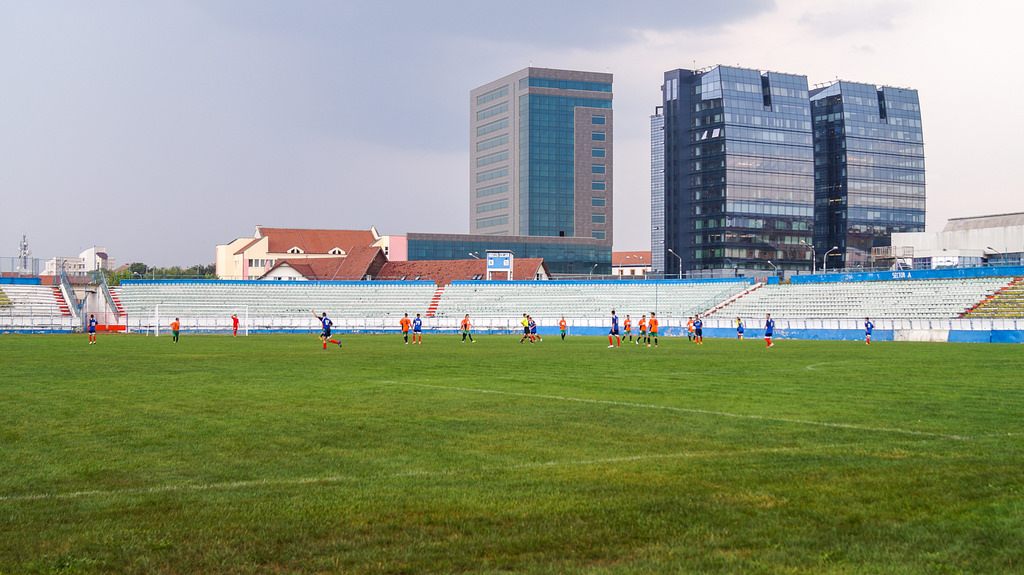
[407,233,611,274]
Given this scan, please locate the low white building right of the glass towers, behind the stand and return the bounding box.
[877,212,1024,268]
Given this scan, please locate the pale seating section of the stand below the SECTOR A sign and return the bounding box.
[714,277,1010,319]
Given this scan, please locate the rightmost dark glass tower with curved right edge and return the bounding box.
[810,81,925,268]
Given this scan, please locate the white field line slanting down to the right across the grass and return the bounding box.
[382,382,971,441]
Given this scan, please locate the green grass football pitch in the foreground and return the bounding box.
[0,334,1024,574]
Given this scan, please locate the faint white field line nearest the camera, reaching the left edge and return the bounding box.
[0,444,855,503]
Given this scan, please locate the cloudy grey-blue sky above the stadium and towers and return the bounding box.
[0,0,1024,266]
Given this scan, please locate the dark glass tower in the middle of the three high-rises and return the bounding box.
[651,65,814,275]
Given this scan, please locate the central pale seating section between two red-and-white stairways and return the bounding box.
[435,279,751,319]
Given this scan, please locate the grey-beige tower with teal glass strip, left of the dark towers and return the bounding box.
[469,68,612,241]
